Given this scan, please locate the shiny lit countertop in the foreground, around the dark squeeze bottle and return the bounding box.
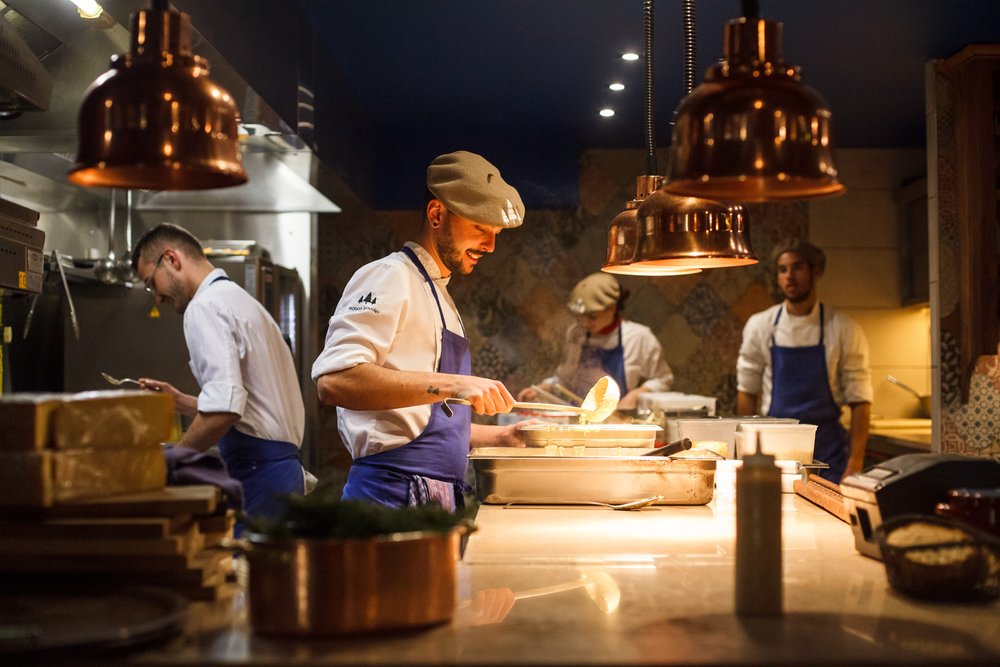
[121,494,1000,665]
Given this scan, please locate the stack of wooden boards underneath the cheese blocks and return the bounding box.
[0,486,234,600]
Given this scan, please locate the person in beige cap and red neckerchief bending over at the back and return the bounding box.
[518,272,674,410]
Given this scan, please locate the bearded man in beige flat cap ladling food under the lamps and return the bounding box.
[312,151,524,509]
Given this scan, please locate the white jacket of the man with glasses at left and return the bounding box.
[184,269,305,447]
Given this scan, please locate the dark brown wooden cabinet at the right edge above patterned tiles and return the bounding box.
[928,44,1000,404]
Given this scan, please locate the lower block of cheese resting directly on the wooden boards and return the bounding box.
[0,445,167,507]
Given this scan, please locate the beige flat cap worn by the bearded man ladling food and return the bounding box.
[427,151,524,227]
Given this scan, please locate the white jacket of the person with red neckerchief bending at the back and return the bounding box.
[545,320,674,391]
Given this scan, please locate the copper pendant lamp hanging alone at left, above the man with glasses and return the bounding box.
[67,0,247,190]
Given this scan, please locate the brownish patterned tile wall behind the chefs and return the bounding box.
[316,150,808,467]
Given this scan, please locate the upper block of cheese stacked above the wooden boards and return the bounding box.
[0,390,174,451]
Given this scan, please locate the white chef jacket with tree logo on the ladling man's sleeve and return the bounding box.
[312,242,465,459]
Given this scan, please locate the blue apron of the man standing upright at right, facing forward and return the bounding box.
[767,304,850,484]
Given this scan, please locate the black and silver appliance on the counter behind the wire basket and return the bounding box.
[840,454,1000,560]
